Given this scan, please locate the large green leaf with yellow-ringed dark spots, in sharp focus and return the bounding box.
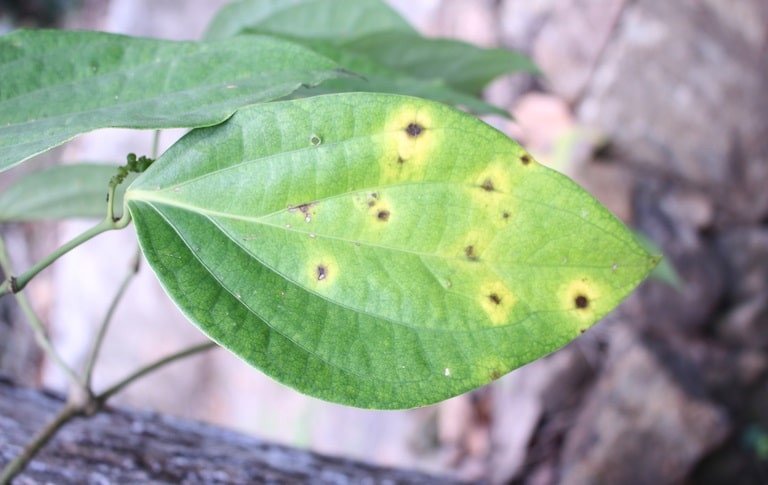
[126,93,657,408]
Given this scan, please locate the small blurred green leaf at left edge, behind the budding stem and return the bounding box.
[0,163,128,222]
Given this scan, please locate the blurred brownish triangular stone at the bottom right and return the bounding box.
[559,329,729,485]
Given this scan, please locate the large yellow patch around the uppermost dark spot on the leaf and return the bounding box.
[381,105,443,181]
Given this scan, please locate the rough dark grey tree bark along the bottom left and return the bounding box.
[0,378,453,485]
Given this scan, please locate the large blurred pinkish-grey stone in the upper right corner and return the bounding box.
[578,0,768,197]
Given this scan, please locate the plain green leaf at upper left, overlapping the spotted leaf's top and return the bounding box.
[0,31,342,171]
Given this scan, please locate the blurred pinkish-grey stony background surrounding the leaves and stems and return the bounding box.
[0,0,768,484]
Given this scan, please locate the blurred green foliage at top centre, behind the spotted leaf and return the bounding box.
[208,0,536,117]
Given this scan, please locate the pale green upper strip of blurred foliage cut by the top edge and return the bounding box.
[206,0,413,41]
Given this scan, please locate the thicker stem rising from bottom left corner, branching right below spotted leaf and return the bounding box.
[0,342,216,485]
